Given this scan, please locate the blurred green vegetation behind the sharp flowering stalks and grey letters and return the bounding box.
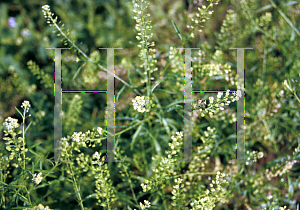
[0,0,300,209]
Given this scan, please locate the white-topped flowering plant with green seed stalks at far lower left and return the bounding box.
[0,101,56,210]
